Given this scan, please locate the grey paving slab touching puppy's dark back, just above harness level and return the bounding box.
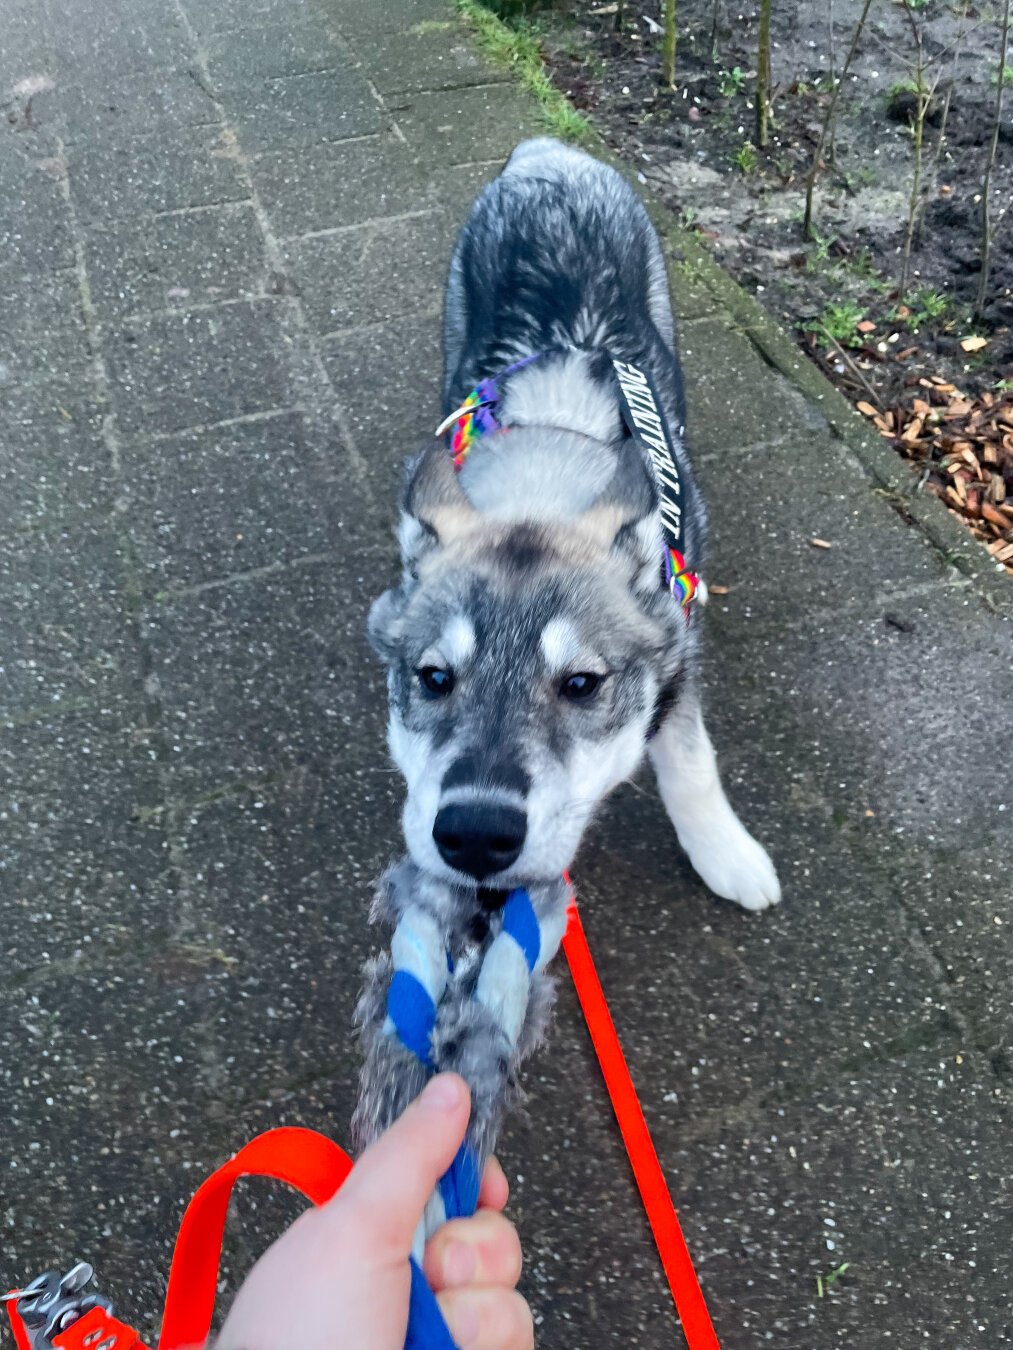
[285,211,455,333]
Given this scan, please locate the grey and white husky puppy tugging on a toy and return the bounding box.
[369,139,781,910]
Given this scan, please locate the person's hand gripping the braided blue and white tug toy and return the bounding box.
[216,1073,534,1350]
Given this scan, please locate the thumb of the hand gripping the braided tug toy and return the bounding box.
[334,1073,471,1261]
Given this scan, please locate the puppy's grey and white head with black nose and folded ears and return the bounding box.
[369,446,687,888]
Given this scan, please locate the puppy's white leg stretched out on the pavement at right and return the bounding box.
[650,687,781,910]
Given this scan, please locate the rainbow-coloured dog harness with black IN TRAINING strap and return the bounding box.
[436,352,701,617]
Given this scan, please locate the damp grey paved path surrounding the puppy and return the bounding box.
[0,0,1013,1350]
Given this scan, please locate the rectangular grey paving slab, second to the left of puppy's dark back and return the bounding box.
[84,203,267,321]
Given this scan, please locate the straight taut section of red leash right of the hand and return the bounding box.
[563,900,719,1350]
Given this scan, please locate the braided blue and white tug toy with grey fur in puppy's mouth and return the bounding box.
[353,861,567,1350]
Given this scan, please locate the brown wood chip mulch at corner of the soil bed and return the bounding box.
[856,378,1013,571]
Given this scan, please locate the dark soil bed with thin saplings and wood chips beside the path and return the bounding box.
[518,0,1013,566]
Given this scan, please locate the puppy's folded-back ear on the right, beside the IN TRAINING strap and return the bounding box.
[579,440,662,591]
